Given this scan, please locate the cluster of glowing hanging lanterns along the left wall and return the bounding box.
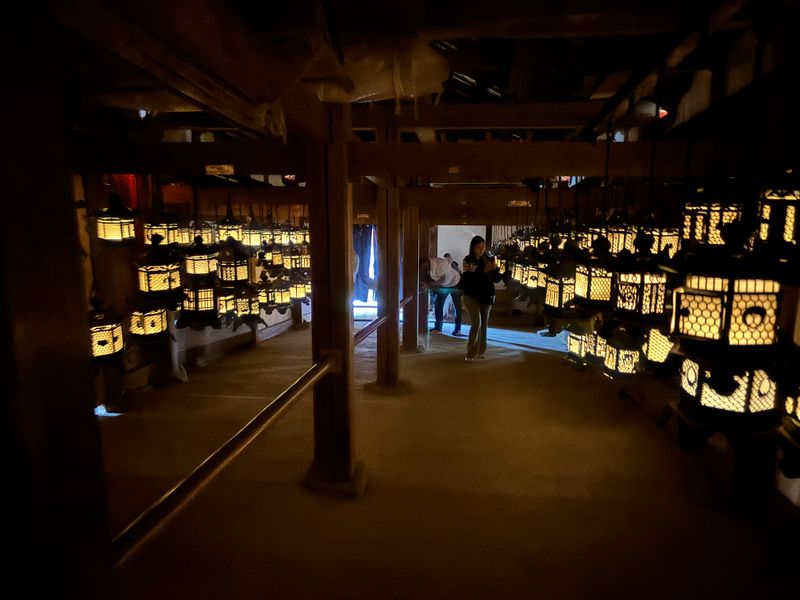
[89,194,311,358]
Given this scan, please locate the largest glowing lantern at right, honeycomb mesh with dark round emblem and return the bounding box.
[673,275,780,346]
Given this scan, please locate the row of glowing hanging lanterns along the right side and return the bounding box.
[506,179,800,443]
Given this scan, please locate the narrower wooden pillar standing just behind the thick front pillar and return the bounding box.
[377,187,400,388]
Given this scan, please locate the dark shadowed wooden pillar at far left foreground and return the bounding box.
[0,15,114,599]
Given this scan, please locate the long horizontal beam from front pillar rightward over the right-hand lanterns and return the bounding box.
[350,142,737,182]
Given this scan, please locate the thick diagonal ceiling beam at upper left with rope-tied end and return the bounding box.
[55,0,324,139]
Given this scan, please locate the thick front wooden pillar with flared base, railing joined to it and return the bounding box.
[305,105,365,495]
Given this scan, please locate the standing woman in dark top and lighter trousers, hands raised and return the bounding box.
[461,235,502,362]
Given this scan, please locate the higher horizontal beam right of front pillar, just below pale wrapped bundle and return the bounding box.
[353,101,603,129]
